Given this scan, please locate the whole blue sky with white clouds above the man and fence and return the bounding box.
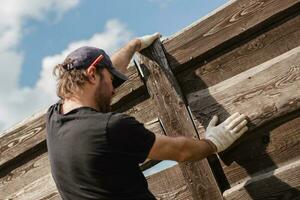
[0,0,226,132]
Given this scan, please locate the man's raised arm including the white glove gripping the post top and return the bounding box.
[111,33,160,73]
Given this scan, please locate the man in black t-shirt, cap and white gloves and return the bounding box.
[47,33,247,200]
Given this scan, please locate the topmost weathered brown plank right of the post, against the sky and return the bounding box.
[163,0,300,71]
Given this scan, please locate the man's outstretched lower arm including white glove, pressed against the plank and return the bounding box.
[148,113,248,162]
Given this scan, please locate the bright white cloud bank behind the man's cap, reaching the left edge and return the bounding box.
[0,20,132,133]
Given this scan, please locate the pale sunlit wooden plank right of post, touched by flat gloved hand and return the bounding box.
[187,47,300,135]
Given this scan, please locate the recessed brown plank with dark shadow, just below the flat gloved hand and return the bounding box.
[219,110,300,187]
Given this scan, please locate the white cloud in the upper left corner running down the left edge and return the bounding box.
[0,0,79,94]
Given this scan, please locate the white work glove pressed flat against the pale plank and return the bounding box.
[205,113,248,153]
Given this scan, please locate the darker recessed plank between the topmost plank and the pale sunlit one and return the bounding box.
[176,12,300,94]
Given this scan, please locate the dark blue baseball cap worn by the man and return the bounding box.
[65,46,128,88]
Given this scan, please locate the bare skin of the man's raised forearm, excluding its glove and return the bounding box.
[111,39,141,73]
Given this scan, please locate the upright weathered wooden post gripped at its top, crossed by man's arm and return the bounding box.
[138,40,223,200]
